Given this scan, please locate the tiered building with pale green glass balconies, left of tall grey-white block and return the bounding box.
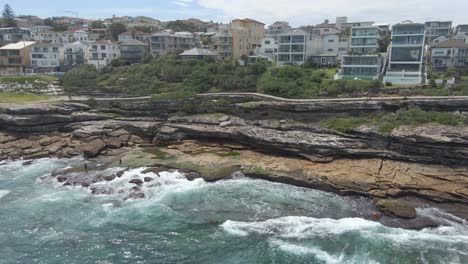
[341,26,384,80]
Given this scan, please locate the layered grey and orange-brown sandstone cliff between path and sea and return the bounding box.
[0,96,468,217]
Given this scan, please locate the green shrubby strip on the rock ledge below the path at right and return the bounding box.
[321,108,465,134]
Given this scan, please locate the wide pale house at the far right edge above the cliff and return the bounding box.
[431,39,468,70]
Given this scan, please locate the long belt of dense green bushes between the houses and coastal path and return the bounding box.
[62,53,381,98]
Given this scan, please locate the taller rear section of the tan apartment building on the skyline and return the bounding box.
[231,18,265,55]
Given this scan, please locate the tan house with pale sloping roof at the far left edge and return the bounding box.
[0,41,35,75]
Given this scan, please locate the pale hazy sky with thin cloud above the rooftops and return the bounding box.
[8,0,468,26]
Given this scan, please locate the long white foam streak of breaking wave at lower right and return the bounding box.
[221,216,468,244]
